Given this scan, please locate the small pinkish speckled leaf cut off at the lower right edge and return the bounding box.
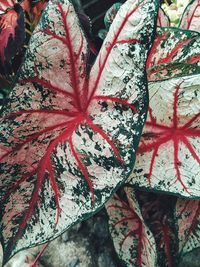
[175,199,200,257]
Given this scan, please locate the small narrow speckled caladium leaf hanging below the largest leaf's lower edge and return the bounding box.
[106,187,157,267]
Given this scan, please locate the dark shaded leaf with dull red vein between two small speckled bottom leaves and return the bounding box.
[136,191,178,267]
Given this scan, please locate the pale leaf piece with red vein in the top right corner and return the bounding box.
[179,0,200,32]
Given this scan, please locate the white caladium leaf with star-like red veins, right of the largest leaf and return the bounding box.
[130,75,200,198]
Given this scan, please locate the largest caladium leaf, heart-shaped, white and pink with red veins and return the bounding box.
[0,0,158,262]
